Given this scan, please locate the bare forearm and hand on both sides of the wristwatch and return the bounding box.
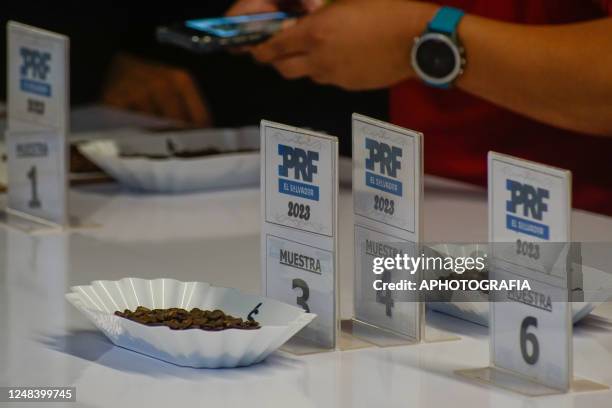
[247,0,612,136]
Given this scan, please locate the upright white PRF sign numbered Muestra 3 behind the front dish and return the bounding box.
[261,121,338,353]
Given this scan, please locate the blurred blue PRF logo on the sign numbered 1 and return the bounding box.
[19,47,51,97]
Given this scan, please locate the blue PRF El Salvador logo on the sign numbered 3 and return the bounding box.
[278,144,319,201]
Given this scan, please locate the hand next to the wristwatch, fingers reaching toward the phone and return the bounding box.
[251,0,438,90]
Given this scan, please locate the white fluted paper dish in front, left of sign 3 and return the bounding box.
[66,278,316,368]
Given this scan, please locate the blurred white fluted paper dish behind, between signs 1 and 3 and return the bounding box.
[77,127,260,193]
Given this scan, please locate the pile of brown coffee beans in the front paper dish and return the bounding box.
[115,306,261,331]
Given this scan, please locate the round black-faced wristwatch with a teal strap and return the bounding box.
[412,7,465,88]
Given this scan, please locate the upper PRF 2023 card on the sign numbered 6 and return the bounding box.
[489,153,571,285]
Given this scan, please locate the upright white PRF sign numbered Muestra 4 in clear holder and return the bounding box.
[353,114,423,345]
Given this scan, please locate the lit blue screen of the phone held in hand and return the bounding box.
[185,12,294,38]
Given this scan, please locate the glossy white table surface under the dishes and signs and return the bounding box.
[0,178,612,408]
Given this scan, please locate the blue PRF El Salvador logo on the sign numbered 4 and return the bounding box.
[365,138,402,197]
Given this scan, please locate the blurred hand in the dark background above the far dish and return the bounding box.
[102,54,212,127]
